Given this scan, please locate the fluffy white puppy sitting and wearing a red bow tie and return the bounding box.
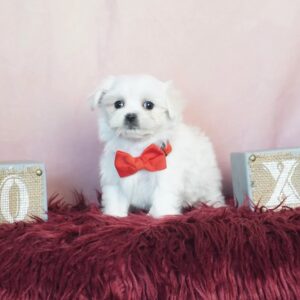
[92,75,224,217]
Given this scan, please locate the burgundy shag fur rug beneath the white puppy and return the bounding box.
[0,196,300,300]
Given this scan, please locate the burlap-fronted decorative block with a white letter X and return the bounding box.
[231,149,300,208]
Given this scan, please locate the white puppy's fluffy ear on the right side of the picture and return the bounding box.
[165,81,184,120]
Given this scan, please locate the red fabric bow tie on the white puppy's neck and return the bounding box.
[115,144,172,177]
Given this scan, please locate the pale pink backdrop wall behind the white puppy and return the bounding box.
[0,0,300,200]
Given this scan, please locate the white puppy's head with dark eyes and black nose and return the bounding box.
[92,75,182,139]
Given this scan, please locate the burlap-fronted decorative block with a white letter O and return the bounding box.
[0,162,48,223]
